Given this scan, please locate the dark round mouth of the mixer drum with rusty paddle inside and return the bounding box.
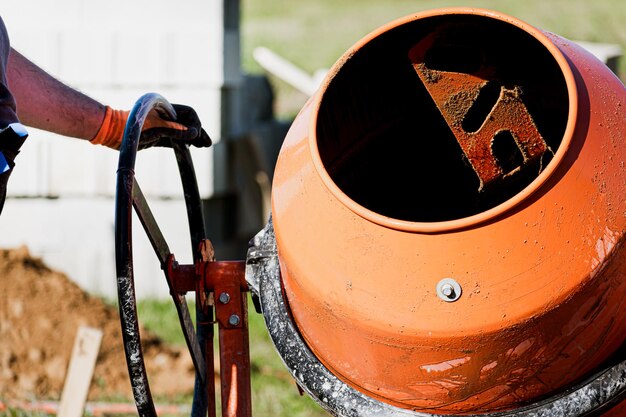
[315,15,568,222]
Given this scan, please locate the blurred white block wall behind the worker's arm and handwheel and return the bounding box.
[0,0,243,297]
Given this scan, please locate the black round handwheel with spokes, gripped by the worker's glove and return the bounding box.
[115,93,214,417]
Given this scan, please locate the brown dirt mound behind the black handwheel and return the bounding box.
[0,248,194,400]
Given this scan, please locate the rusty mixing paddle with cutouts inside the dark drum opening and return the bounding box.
[409,27,548,191]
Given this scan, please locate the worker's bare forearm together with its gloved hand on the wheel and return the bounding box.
[7,49,211,149]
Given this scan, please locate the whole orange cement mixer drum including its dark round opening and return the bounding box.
[272,9,626,414]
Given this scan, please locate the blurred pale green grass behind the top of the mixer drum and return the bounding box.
[241,0,626,117]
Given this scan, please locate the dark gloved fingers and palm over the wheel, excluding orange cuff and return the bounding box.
[139,104,211,149]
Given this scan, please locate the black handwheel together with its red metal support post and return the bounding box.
[115,93,251,417]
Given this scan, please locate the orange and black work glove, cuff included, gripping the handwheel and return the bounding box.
[91,104,211,149]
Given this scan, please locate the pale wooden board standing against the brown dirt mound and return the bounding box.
[57,326,102,417]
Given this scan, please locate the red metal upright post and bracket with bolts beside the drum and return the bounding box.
[167,242,252,417]
